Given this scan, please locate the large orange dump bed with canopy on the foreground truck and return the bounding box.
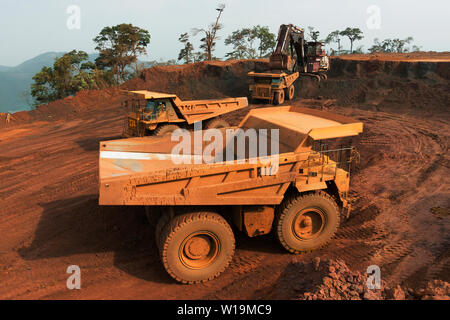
[99,107,362,205]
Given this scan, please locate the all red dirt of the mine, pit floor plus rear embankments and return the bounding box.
[0,56,450,299]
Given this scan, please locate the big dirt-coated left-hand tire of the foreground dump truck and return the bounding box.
[159,212,235,284]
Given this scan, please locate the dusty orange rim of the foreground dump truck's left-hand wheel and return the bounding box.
[179,231,220,269]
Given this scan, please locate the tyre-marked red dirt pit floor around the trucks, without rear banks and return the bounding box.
[0,55,450,299]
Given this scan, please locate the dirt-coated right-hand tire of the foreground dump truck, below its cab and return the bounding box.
[275,191,340,253]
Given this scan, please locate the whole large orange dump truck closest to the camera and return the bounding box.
[99,107,363,283]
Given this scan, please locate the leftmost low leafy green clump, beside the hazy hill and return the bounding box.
[31,50,112,104]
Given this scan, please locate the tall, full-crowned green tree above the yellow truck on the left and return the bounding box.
[93,23,150,83]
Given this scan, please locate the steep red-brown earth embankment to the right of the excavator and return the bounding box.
[297,55,450,115]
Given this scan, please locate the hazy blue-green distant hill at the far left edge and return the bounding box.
[0,52,98,112]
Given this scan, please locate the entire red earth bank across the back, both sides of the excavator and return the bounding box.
[0,53,450,128]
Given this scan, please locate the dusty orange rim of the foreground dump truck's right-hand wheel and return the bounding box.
[292,208,325,240]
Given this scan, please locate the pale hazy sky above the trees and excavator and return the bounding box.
[0,0,450,66]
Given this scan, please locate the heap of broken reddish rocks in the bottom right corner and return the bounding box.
[280,258,450,300]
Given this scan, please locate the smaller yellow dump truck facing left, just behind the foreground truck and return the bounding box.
[123,90,248,137]
